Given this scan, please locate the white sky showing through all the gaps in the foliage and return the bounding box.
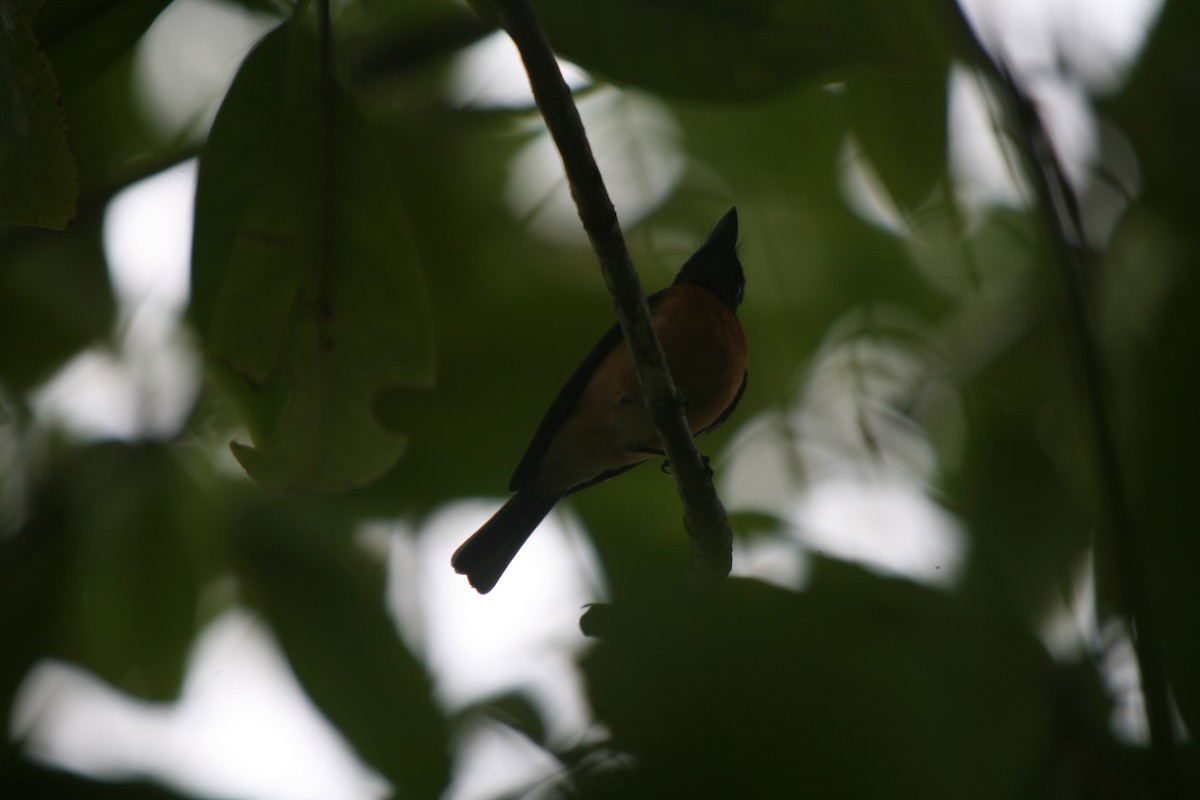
[11,0,1159,800]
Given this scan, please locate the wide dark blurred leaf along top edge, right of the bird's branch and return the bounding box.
[473,0,889,102]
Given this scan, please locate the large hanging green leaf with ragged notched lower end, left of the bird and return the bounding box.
[192,25,432,491]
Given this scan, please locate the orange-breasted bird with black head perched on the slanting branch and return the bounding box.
[450,207,749,594]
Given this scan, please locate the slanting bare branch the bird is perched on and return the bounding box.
[493,0,733,584]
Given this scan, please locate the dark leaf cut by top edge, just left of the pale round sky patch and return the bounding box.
[34,0,172,84]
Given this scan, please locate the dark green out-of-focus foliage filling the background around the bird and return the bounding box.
[0,0,1200,799]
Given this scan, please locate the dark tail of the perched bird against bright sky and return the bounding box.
[450,487,562,595]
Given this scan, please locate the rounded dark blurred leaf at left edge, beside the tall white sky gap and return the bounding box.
[0,210,116,392]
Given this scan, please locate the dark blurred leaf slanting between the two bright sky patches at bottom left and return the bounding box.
[238,499,450,798]
